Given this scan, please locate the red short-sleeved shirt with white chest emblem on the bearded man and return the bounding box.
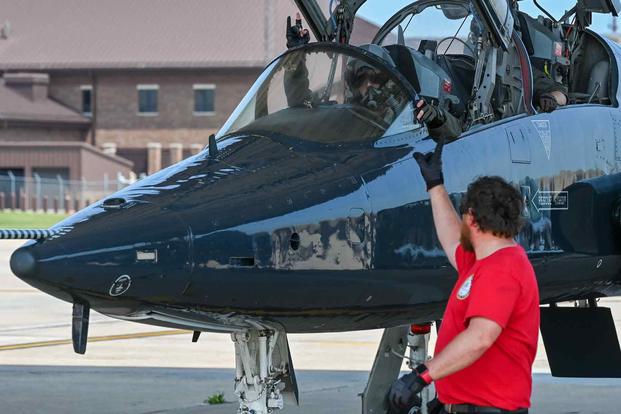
[435,246,539,410]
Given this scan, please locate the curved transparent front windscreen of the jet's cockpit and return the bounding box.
[218,46,419,144]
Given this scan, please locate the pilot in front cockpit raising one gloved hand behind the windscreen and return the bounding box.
[285,13,462,142]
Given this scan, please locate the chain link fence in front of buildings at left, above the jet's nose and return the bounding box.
[0,173,130,213]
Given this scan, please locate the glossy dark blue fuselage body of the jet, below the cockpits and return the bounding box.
[12,105,621,332]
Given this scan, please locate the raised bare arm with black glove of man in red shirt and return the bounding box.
[414,139,461,268]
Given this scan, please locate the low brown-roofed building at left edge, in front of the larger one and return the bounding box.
[0,73,132,180]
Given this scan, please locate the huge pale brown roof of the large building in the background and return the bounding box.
[0,0,388,71]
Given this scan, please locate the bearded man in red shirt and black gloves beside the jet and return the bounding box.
[388,141,539,414]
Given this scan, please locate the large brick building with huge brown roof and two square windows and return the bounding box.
[0,0,377,177]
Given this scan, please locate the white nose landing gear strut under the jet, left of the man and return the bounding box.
[231,330,298,414]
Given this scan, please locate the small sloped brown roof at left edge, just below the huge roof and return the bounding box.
[0,78,91,127]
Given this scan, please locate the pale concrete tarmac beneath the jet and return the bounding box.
[0,241,621,414]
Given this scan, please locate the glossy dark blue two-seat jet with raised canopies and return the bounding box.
[2,0,621,413]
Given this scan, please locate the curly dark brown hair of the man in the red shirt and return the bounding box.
[459,176,524,238]
